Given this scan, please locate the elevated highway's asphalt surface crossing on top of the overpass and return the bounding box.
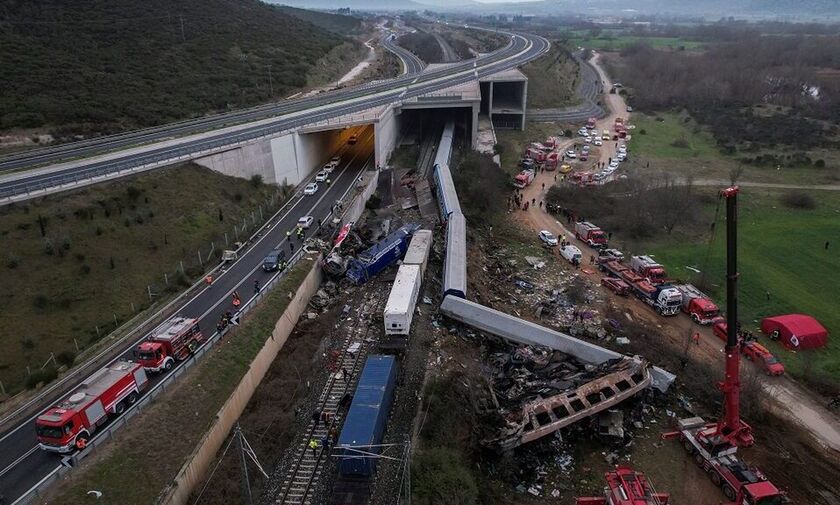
[0,30,549,202]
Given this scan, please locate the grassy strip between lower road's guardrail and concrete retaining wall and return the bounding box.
[50,259,313,505]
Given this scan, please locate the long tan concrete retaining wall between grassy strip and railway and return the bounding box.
[160,261,322,505]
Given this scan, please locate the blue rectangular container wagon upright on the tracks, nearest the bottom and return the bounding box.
[336,355,397,477]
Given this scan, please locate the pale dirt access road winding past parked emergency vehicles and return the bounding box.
[514,54,840,456]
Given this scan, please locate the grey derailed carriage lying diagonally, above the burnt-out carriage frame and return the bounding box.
[440,295,677,393]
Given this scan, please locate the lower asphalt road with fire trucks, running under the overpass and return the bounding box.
[0,127,373,503]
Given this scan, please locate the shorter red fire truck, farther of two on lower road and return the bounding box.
[134,316,204,372]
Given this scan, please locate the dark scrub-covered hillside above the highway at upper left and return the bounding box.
[0,0,346,133]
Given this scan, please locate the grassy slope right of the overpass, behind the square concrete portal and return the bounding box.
[522,44,580,108]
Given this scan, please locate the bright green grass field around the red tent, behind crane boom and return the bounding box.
[646,188,840,382]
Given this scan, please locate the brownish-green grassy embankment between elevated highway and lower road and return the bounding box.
[0,165,277,392]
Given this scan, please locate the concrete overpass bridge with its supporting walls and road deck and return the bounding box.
[0,29,549,205]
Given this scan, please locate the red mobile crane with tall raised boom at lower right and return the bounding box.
[664,186,787,505]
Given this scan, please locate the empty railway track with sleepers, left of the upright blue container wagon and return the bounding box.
[275,293,384,505]
